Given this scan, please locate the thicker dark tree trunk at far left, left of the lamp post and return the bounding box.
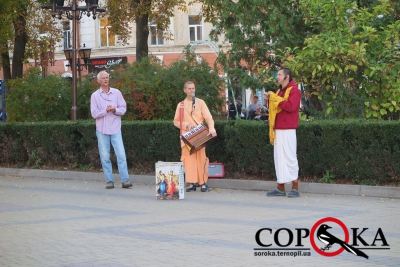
[12,10,27,79]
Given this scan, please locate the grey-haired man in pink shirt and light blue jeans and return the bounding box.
[90,71,132,189]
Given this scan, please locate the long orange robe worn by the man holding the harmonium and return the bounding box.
[174,98,215,185]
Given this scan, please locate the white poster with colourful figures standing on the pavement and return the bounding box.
[156,161,185,200]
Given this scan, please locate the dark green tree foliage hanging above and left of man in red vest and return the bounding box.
[203,0,308,88]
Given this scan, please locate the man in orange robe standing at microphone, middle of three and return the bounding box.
[174,81,217,192]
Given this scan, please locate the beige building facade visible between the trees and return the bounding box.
[30,1,227,75]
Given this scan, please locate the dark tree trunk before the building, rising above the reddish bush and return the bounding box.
[133,0,151,61]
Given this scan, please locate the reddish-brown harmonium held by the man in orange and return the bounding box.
[181,123,213,154]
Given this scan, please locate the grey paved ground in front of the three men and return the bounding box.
[0,175,400,267]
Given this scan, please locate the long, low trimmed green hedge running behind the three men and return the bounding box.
[0,120,400,185]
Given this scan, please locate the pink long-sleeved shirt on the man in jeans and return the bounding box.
[90,88,126,135]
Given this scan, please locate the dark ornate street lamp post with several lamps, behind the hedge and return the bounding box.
[42,0,105,120]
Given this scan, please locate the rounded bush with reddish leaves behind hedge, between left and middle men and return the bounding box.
[111,54,224,120]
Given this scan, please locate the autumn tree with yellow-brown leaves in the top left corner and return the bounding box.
[0,0,61,80]
